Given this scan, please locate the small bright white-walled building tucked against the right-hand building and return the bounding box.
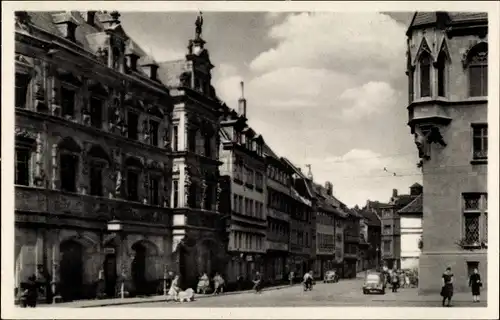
[398,194,423,269]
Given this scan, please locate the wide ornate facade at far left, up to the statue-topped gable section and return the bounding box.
[15,11,172,300]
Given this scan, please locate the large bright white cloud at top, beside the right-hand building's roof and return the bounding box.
[250,12,405,80]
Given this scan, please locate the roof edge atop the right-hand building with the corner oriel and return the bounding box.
[407,11,488,33]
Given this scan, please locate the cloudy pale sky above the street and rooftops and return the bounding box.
[121,12,421,206]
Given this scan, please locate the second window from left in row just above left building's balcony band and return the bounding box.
[59,137,81,192]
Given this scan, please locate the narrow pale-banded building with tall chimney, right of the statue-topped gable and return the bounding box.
[220,82,267,282]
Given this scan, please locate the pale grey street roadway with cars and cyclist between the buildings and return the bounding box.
[120,278,486,308]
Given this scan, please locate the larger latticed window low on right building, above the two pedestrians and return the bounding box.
[462,193,488,246]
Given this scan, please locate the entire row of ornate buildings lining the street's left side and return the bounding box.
[15,11,380,300]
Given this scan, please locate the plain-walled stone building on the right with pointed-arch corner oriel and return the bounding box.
[407,12,488,292]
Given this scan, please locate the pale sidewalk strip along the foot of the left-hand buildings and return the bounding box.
[37,283,302,308]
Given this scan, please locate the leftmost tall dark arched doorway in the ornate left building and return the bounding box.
[59,240,83,301]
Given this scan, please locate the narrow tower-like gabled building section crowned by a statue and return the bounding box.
[155,14,227,287]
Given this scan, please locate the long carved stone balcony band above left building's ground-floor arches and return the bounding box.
[15,186,171,226]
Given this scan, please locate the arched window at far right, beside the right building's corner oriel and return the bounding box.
[467,43,488,97]
